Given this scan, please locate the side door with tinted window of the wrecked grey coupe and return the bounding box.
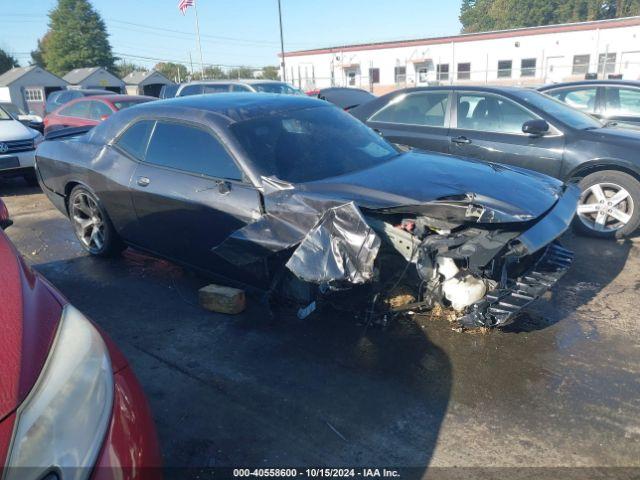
[126,121,261,274]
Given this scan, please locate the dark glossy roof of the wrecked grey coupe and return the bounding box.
[128,93,327,122]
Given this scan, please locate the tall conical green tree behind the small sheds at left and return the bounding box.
[42,0,116,75]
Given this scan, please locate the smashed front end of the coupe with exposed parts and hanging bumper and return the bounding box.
[366,185,579,327]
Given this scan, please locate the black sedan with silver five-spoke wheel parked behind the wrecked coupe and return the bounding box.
[350,86,640,238]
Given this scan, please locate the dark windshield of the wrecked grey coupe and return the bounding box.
[231,106,398,183]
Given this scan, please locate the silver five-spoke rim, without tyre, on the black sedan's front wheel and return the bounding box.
[578,183,635,232]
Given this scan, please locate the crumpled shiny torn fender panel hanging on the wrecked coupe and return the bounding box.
[286,203,380,284]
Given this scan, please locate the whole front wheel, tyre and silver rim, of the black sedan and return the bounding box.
[573,170,640,238]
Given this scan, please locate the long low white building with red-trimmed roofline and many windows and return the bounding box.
[281,17,640,93]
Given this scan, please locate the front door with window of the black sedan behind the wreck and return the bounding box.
[449,91,564,177]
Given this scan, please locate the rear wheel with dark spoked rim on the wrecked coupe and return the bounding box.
[68,186,124,257]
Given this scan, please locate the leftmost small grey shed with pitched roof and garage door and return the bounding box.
[0,65,67,115]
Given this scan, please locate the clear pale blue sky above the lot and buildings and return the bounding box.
[0,0,461,68]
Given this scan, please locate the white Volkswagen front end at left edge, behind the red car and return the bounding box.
[0,107,43,185]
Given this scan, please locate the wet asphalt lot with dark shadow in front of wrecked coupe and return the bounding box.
[0,180,640,478]
